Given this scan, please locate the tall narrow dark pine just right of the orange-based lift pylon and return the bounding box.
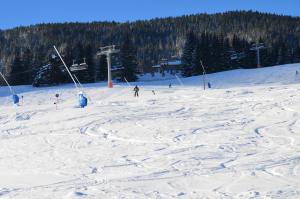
[121,35,138,81]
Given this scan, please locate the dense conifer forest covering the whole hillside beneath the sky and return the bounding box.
[0,11,300,84]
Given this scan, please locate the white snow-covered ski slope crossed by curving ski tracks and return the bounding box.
[0,64,300,199]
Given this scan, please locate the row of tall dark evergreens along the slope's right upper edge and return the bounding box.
[182,31,300,76]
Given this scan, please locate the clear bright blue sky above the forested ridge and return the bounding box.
[0,0,300,29]
